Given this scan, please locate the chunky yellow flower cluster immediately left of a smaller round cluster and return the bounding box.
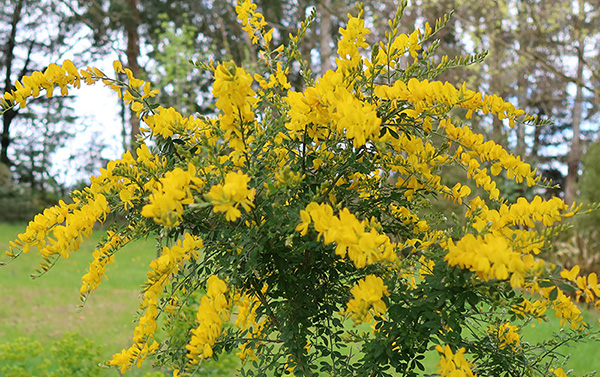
[142,163,204,228]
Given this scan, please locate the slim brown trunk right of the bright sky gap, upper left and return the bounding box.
[123,0,140,155]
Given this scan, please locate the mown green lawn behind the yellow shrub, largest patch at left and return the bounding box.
[0,224,600,377]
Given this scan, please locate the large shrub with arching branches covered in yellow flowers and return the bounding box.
[0,0,600,376]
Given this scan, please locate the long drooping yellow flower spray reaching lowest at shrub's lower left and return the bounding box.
[107,233,204,373]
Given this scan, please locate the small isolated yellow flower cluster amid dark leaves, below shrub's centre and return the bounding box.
[346,275,389,323]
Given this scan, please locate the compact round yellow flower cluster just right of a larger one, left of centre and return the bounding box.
[206,171,256,221]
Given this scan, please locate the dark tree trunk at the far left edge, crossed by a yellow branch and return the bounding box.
[0,0,23,165]
